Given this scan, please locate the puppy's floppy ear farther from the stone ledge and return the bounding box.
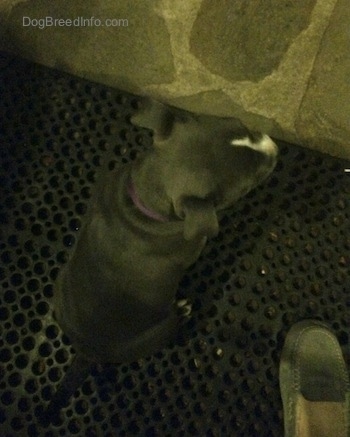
[183,199,219,241]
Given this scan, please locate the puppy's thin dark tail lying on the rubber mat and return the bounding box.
[42,354,94,424]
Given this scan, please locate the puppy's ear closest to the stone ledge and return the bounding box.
[131,97,175,141]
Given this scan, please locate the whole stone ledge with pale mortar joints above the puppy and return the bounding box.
[0,0,350,159]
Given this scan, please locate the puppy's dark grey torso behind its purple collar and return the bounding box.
[54,165,205,362]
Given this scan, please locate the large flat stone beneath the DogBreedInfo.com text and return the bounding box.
[0,0,174,92]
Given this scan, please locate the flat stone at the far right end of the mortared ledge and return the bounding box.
[296,0,350,158]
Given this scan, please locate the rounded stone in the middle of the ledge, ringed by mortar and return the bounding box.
[190,0,316,82]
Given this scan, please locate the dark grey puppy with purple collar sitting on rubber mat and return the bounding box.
[46,99,277,416]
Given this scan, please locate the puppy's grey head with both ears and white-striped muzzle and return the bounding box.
[131,99,277,240]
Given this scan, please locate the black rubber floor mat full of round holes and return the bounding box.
[0,52,350,437]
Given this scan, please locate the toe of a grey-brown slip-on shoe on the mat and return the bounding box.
[279,320,350,437]
